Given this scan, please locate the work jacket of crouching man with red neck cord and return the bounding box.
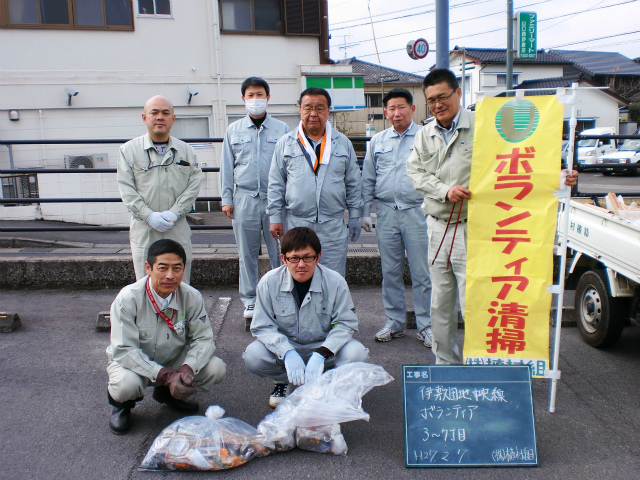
[107,276,216,382]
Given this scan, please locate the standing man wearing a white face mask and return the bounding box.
[220,77,289,318]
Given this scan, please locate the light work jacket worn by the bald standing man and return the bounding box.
[118,133,202,247]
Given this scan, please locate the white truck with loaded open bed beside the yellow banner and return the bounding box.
[558,194,640,348]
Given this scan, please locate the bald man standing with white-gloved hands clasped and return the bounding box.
[118,95,202,283]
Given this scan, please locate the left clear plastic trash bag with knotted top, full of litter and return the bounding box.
[140,405,264,471]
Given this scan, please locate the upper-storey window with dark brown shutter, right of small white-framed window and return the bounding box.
[220,0,323,35]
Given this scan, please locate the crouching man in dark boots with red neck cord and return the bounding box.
[107,239,227,434]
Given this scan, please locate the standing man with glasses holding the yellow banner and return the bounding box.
[407,69,577,364]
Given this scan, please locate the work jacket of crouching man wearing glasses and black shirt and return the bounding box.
[251,264,358,359]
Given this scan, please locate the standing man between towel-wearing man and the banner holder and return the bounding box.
[362,88,433,348]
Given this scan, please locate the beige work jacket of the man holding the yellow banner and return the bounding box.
[407,110,475,222]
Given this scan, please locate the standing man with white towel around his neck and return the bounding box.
[267,87,362,277]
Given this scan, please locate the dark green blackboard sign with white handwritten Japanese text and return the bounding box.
[402,365,538,467]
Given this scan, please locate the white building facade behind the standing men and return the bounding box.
[0,0,362,225]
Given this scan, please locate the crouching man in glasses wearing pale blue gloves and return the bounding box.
[243,227,369,408]
